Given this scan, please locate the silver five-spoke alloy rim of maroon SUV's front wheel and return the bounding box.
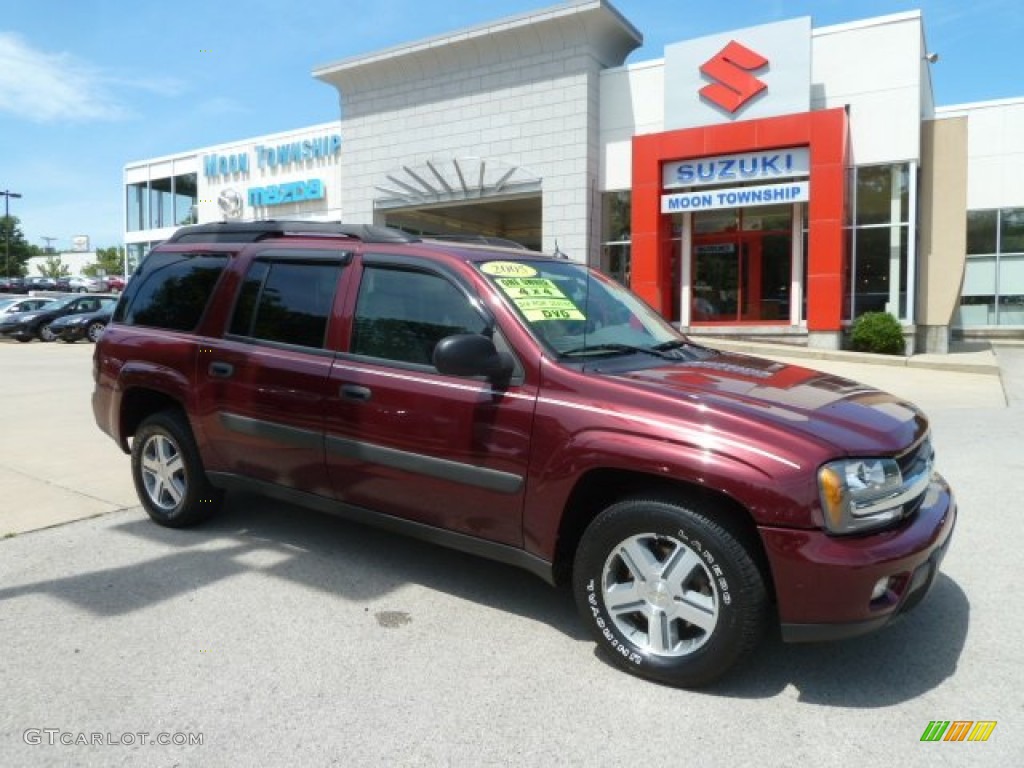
[601,534,719,657]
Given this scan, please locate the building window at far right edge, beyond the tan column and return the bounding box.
[956,208,1024,328]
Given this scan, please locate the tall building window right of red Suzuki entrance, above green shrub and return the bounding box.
[845,163,916,322]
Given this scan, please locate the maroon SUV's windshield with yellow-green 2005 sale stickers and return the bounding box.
[477,260,685,356]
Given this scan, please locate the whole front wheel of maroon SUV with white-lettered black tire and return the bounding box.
[572,499,768,687]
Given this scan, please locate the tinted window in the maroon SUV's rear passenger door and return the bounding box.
[229,260,342,349]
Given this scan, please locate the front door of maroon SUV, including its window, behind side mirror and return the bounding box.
[327,255,537,546]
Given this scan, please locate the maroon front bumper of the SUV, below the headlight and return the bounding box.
[761,475,956,642]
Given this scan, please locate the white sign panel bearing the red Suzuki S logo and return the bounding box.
[665,16,811,130]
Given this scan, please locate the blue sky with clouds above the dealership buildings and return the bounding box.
[0,0,1024,250]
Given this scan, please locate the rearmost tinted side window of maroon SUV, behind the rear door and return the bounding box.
[114,252,227,331]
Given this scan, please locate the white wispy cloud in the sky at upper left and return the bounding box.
[0,33,182,123]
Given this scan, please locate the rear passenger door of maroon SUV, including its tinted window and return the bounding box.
[196,248,351,497]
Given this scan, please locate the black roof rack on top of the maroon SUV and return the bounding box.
[166,219,420,243]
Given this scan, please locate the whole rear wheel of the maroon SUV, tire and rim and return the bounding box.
[131,411,223,528]
